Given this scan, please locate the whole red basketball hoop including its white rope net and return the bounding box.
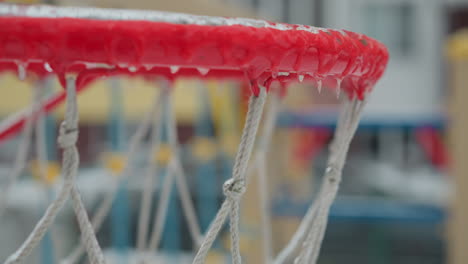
[0,4,388,264]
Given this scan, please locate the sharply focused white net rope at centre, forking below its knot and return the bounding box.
[193,87,267,264]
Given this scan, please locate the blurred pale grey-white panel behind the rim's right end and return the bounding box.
[323,0,444,120]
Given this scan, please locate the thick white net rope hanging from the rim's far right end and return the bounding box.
[275,99,365,264]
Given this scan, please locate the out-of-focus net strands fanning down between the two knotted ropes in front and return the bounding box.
[62,82,202,263]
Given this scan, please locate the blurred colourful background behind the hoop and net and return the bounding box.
[0,0,468,264]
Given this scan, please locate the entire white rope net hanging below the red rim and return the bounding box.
[0,5,364,264]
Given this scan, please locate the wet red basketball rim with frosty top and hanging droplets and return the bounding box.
[0,4,388,140]
